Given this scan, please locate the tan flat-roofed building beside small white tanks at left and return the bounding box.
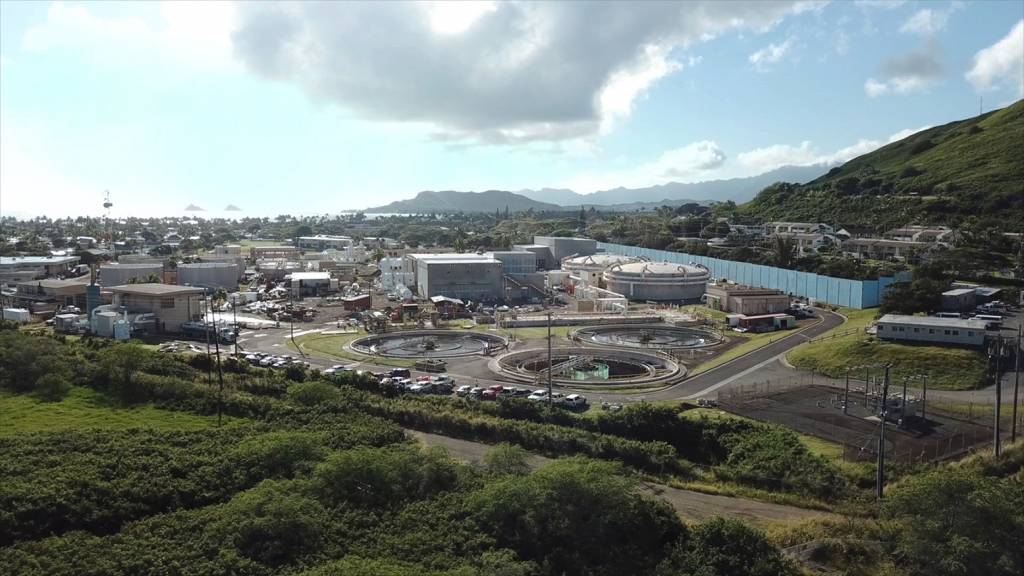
[111,283,203,332]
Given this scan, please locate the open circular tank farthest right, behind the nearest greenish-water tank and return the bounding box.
[570,324,722,351]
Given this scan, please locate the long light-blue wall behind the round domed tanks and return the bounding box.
[597,242,910,308]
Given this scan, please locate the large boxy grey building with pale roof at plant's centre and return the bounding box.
[406,254,505,300]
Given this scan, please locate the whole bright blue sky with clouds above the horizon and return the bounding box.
[0,0,1024,217]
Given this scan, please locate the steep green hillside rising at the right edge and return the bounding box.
[742,100,1024,230]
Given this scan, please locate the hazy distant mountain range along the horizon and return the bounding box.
[366,165,827,214]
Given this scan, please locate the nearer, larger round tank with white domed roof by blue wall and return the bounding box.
[604,262,710,302]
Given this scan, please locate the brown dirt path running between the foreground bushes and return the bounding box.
[407,430,829,524]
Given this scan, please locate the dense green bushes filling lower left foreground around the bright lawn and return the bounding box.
[0,330,815,576]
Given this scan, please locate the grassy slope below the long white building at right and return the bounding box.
[786,310,986,390]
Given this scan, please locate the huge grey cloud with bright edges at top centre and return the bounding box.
[232,0,817,142]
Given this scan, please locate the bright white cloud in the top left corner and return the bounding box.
[22,0,237,68]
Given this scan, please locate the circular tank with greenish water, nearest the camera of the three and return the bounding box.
[490,346,685,385]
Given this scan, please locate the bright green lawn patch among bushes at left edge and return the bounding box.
[0,387,228,437]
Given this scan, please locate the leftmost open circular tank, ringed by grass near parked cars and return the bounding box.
[349,330,508,359]
